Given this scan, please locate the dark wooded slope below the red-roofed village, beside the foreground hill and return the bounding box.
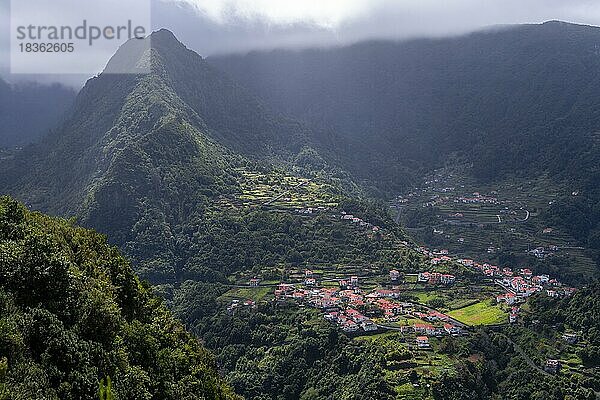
[183,304,394,399]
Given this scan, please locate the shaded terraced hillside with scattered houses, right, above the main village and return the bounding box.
[399,170,597,280]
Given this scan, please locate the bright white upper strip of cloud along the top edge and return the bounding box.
[161,0,600,34]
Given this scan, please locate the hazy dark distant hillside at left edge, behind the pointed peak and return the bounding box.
[0,79,75,147]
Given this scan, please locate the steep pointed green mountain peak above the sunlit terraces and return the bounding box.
[0,30,342,280]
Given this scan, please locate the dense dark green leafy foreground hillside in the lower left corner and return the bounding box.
[0,197,234,399]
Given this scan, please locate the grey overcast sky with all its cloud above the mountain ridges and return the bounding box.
[0,0,600,84]
